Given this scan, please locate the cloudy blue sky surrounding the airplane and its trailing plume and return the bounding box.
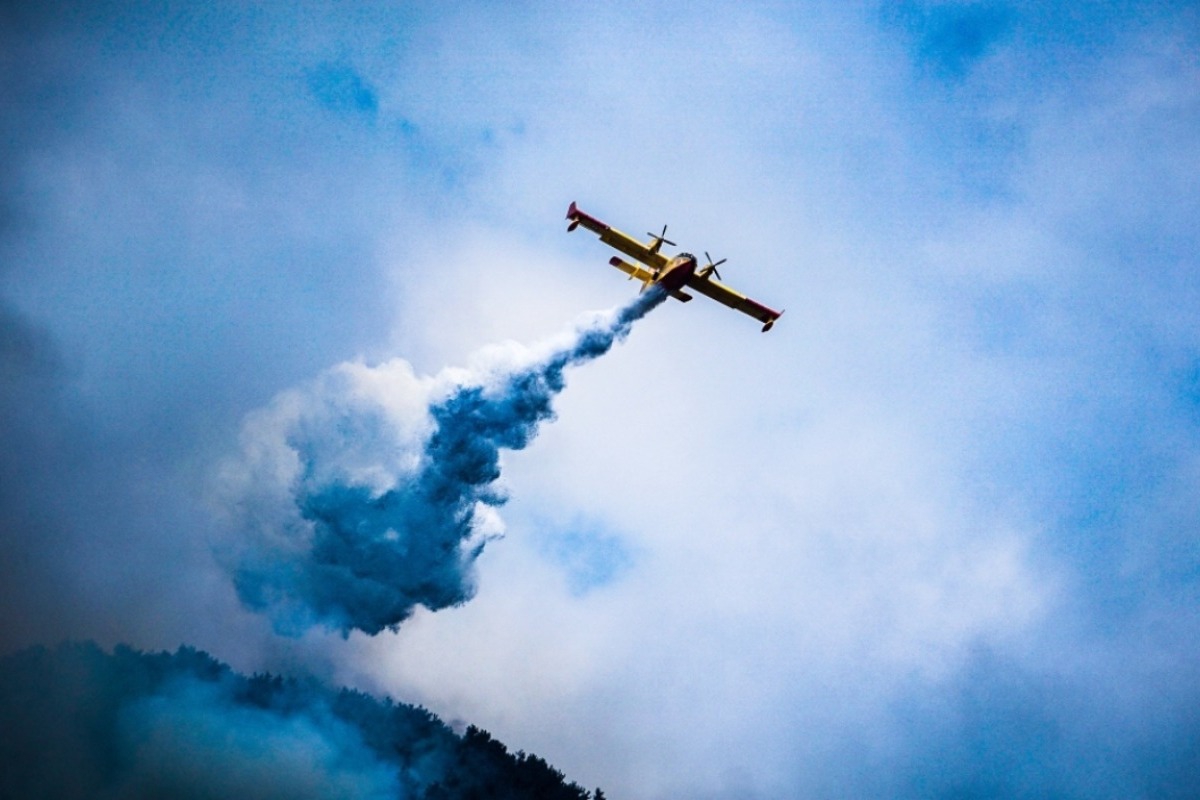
[0,2,1200,798]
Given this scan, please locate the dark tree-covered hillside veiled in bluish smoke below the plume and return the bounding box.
[0,643,604,800]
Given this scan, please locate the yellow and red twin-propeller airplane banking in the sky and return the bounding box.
[566,203,784,333]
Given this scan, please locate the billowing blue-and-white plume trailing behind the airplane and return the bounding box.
[223,287,666,634]
